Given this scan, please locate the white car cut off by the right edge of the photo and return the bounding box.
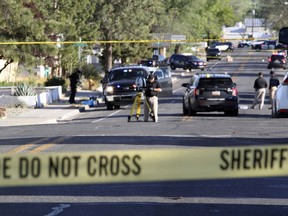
[271,72,288,118]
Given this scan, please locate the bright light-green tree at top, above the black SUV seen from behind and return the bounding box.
[161,0,237,51]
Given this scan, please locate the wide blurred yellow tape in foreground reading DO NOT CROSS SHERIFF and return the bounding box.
[0,145,288,187]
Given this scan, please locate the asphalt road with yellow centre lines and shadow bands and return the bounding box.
[0,48,288,216]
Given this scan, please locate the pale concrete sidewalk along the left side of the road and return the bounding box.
[0,91,102,127]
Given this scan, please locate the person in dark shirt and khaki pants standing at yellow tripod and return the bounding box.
[144,74,162,122]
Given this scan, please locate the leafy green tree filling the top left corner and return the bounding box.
[0,0,52,72]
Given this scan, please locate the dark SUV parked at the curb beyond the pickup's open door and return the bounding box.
[169,54,206,70]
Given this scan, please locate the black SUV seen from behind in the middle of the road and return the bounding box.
[182,74,239,116]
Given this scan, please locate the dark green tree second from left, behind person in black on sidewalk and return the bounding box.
[38,0,98,75]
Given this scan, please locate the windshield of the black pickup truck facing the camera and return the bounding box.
[109,68,148,81]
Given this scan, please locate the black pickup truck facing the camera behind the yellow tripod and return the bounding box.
[103,66,149,110]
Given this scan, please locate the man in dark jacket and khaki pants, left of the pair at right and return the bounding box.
[251,72,268,110]
